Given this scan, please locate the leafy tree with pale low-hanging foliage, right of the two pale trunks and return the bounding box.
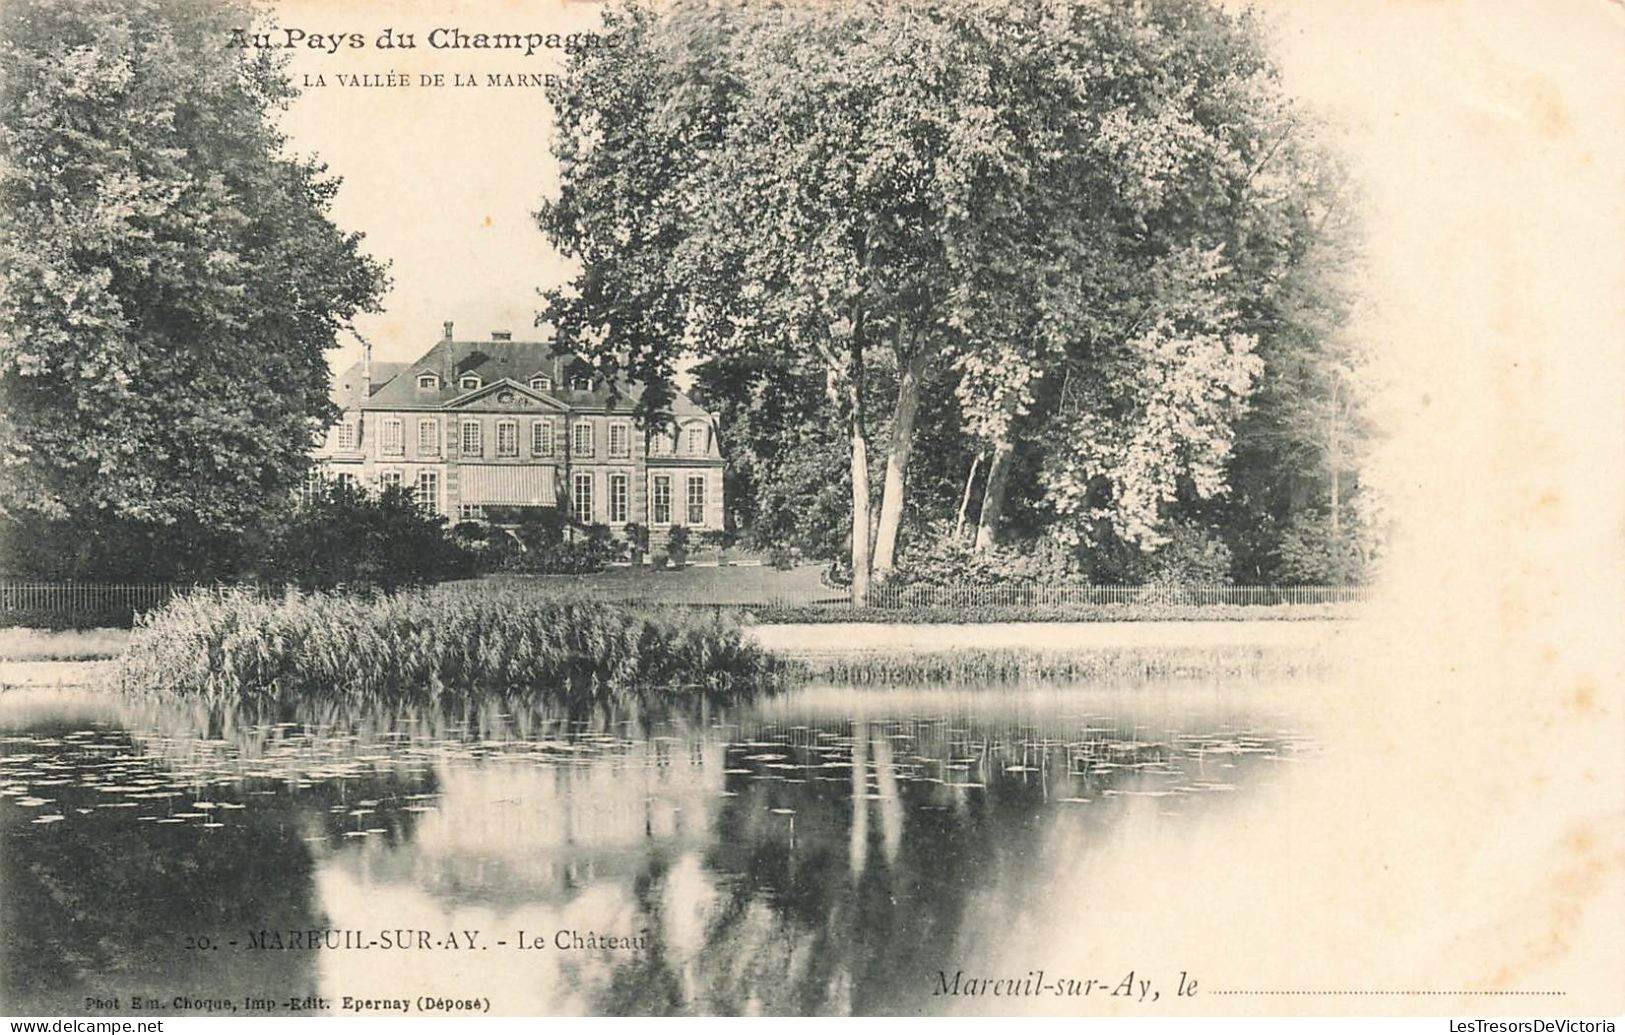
[957,0,1316,565]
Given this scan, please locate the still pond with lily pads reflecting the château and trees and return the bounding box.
[0,682,1318,1016]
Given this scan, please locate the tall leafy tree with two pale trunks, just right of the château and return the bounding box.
[540,3,975,598]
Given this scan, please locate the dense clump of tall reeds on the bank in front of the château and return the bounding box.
[119,590,782,705]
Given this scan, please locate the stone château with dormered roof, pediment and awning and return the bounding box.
[315,323,723,539]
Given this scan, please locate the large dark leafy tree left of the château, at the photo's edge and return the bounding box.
[0,0,384,575]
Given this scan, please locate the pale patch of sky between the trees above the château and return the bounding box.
[273,0,598,367]
